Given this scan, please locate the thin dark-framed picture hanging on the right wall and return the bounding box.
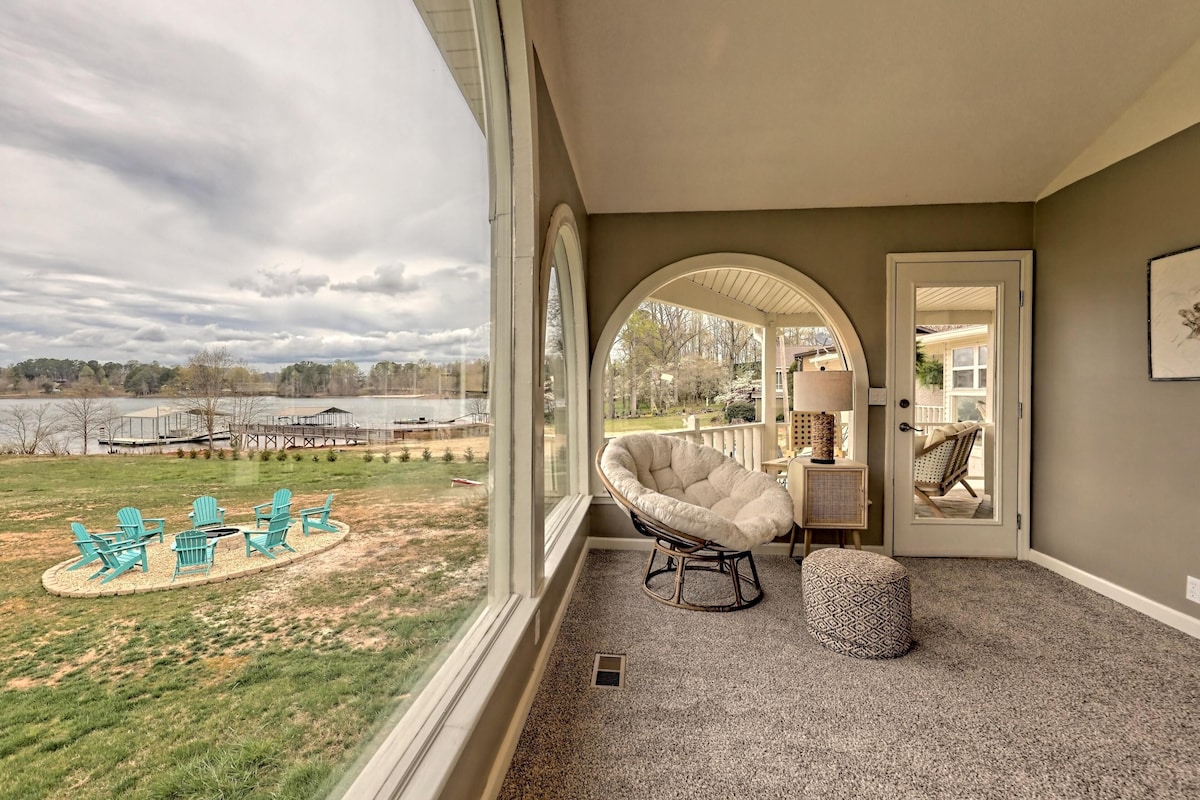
[1146,245,1200,380]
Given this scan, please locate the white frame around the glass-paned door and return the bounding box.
[883,249,1033,560]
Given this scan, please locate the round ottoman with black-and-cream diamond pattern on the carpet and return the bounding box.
[800,548,912,658]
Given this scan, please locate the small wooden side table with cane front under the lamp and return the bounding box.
[787,458,866,558]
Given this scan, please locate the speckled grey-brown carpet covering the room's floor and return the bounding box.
[500,551,1200,800]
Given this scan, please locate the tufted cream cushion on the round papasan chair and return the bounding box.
[600,433,792,549]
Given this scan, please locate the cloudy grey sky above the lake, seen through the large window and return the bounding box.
[0,0,490,368]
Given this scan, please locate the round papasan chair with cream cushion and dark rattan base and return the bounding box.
[596,433,792,612]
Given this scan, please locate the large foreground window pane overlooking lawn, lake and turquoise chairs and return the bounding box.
[0,0,492,798]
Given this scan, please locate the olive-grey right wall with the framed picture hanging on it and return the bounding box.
[1031,126,1200,616]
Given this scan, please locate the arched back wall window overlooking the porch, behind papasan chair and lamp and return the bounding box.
[593,253,866,484]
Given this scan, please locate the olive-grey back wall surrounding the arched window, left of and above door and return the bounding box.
[588,203,1033,545]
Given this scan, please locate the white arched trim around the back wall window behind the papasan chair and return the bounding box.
[590,253,870,494]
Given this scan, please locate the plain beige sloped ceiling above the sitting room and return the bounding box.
[547,0,1200,213]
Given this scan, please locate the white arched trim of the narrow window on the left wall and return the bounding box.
[539,203,590,520]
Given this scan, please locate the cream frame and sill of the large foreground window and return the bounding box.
[331,0,549,799]
